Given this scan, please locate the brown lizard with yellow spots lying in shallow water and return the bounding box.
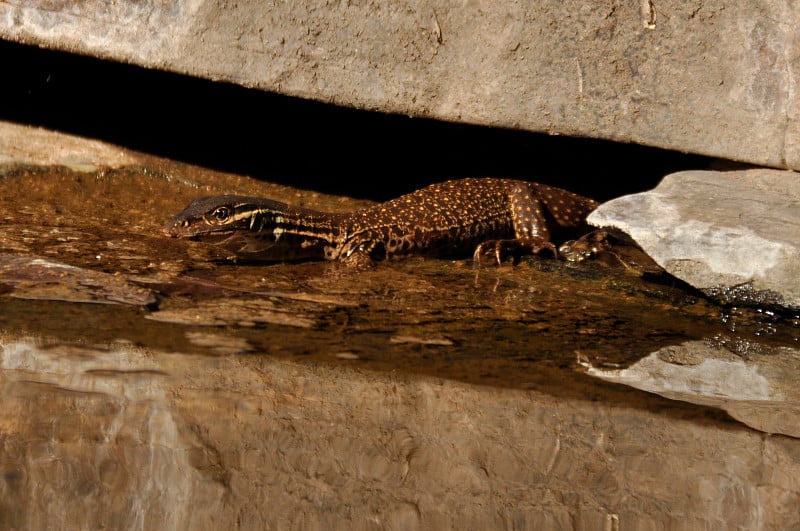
[164,178,598,263]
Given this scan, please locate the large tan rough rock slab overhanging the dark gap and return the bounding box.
[0,0,800,168]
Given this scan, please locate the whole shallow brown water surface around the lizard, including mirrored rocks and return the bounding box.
[0,124,800,529]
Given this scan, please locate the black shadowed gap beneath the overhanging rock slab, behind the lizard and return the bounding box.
[0,41,709,200]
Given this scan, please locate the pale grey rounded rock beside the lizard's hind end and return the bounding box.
[588,169,800,308]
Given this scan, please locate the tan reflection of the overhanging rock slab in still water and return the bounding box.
[0,337,800,529]
